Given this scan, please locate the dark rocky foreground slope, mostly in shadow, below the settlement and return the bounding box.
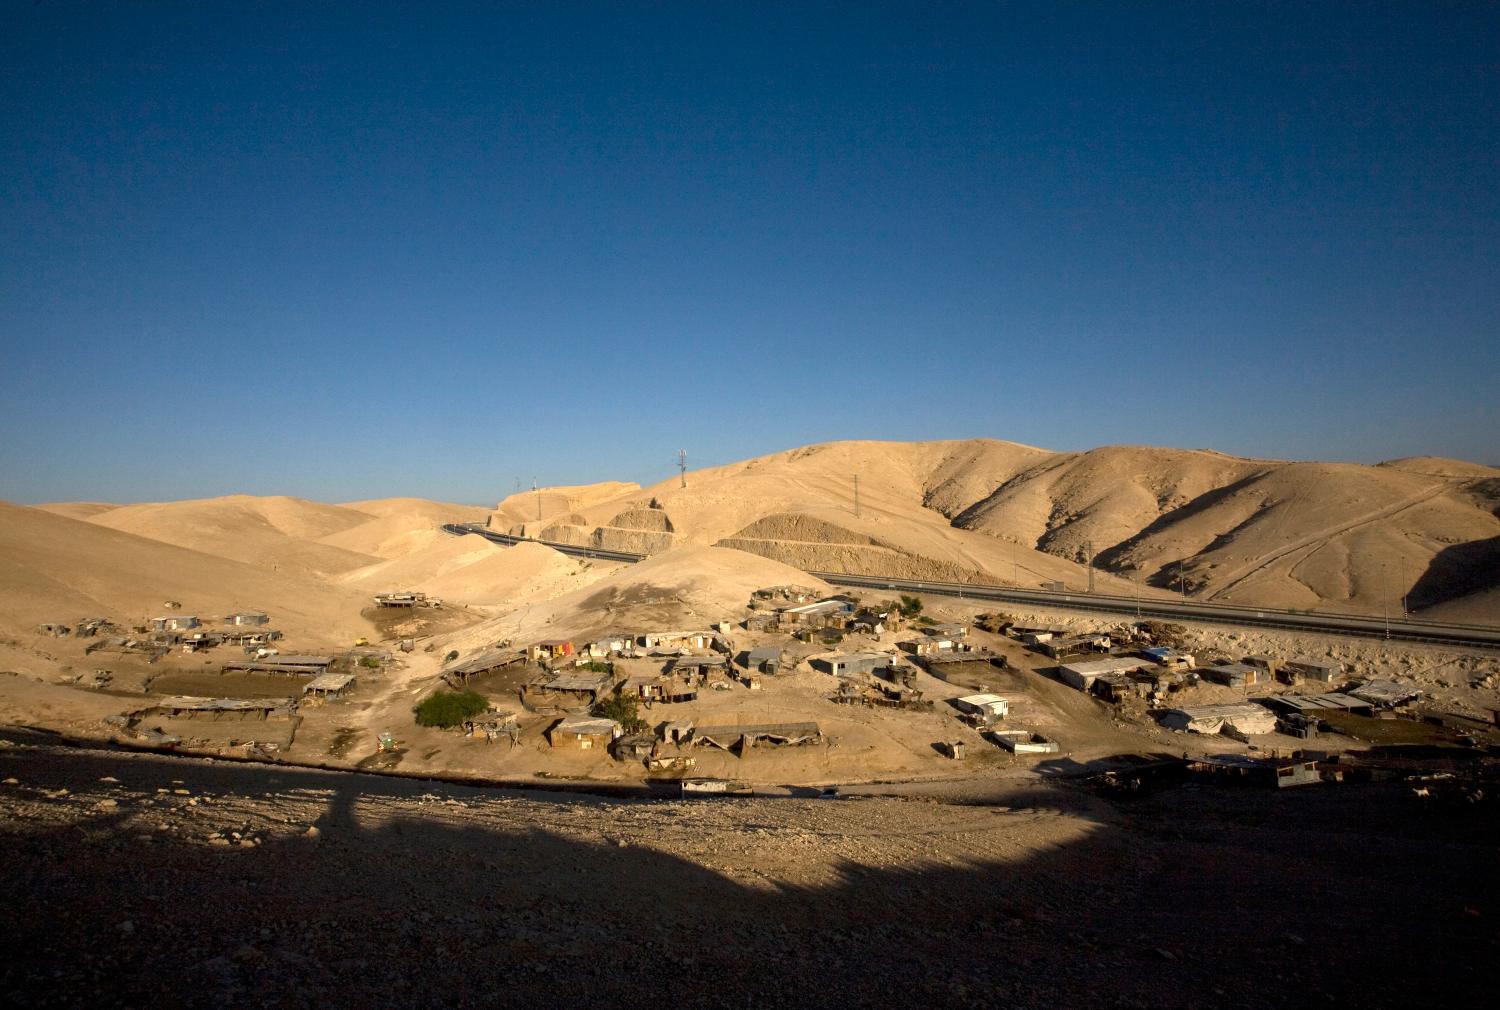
[0,731,1500,1007]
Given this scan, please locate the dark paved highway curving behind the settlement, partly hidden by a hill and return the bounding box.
[443,524,1500,650]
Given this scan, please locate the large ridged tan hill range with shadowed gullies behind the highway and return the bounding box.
[489,440,1500,620]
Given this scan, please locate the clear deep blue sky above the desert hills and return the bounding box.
[0,0,1500,501]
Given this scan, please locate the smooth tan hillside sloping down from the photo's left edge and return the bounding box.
[0,503,368,642]
